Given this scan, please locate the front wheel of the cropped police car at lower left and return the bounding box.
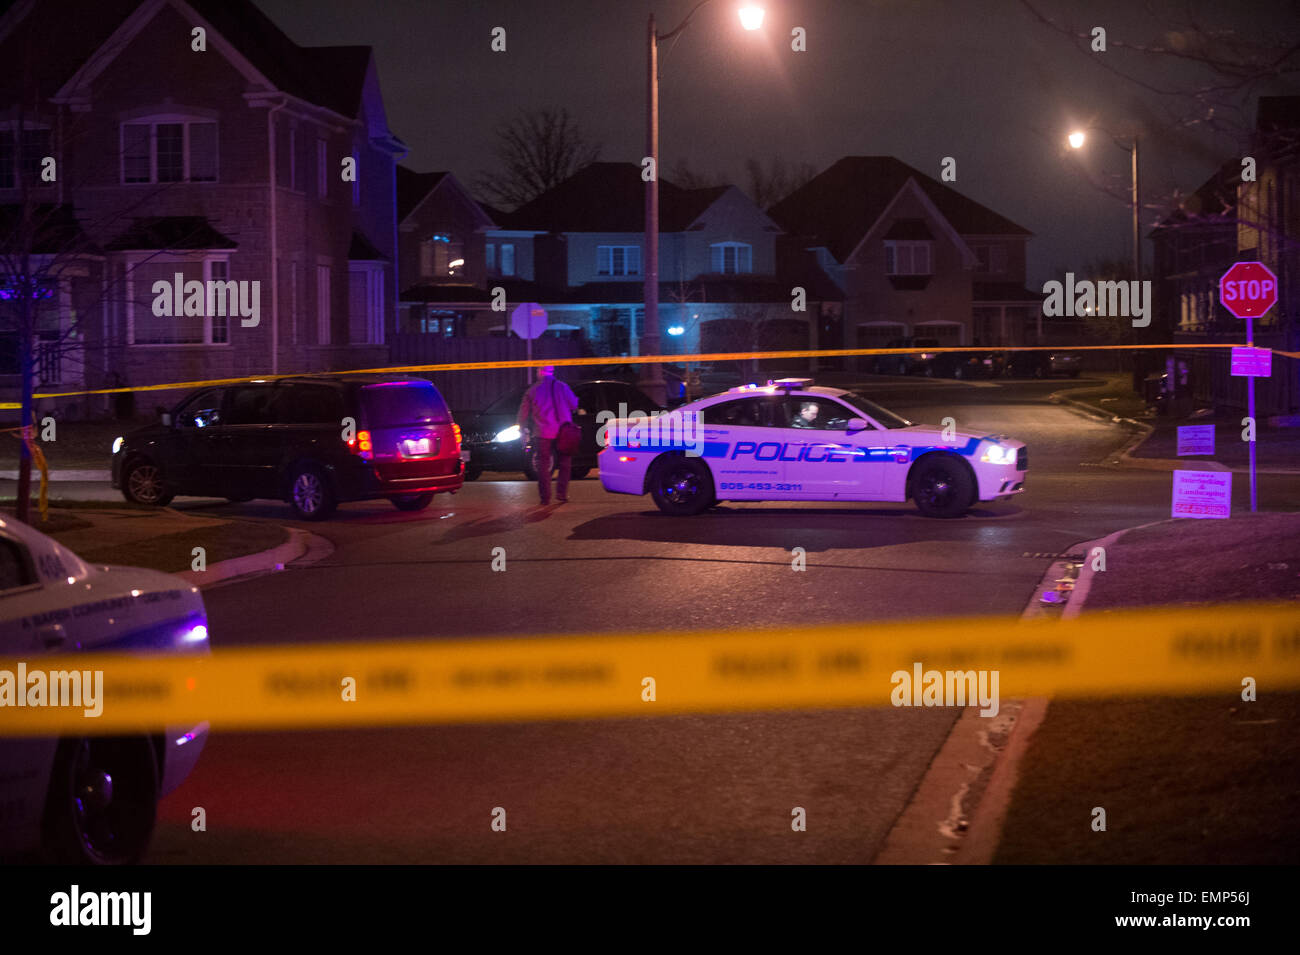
[42,737,159,865]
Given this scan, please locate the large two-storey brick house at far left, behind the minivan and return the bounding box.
[0,0,404,415]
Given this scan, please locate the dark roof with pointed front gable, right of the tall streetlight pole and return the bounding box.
[768,156,1034,262]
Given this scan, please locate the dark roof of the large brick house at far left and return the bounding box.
[0,0,371,118]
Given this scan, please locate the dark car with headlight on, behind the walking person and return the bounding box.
[460,378,662,481]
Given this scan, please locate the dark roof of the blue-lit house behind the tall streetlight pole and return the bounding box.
[493,162,731,233]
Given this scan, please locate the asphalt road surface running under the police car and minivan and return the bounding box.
[94,381,1294,863]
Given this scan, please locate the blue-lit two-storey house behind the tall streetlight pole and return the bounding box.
[472,162,836,355]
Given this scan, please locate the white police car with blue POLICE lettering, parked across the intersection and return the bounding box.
[599,378,1027,517]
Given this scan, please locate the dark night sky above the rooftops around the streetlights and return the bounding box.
[256,0,1300,287]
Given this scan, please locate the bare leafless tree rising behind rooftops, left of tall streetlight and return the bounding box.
[475,107,601,209]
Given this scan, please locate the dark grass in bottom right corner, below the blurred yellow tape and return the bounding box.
[993,687,1300,865]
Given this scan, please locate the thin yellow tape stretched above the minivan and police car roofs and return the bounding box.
[0,342,1258,409]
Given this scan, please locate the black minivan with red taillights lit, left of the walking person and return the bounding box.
[113,376,464,521]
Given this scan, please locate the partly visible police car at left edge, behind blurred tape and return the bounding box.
[0,518,208,864]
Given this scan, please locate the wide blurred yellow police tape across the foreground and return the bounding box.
[0,604,1300,735]
